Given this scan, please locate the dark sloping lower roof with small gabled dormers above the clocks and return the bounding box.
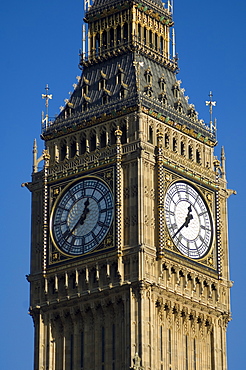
[44,52,215,142]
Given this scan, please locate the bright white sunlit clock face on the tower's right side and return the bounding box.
[164,181,213,259]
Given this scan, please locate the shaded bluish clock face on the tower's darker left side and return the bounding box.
[50,177,113,256]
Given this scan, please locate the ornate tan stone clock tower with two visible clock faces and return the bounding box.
[26,0,231,370]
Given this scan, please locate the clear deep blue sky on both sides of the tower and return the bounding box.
[0,0,246,370]
